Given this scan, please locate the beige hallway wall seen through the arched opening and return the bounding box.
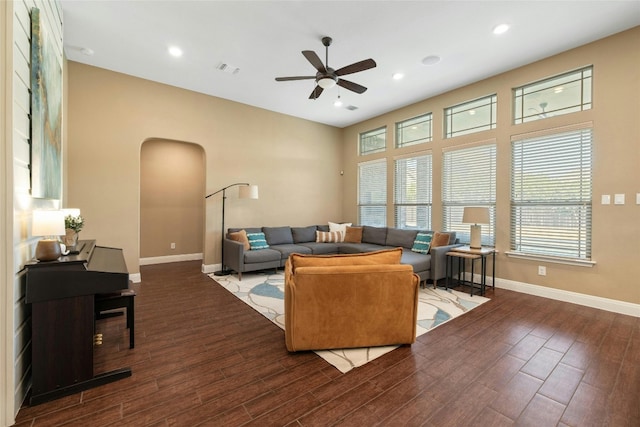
[140,139,205,258]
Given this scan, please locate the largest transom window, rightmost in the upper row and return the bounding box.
[513,67,593,124]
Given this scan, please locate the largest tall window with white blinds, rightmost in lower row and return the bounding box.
[511,129,592,260]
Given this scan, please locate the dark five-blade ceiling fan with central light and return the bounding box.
[276,37,376,99]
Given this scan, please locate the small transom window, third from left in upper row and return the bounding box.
[444,95,498,138]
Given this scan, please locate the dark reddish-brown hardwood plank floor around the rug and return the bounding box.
[16,261,640,427]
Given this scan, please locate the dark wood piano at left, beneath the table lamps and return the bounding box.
[25,240,131,405]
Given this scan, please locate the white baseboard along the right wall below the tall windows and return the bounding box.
[492,276,640,317]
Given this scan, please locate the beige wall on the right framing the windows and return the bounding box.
[343,27,640,304]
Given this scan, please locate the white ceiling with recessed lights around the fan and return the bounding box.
[61,0,640,127]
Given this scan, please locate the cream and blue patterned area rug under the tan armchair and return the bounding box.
[209,272,489,373]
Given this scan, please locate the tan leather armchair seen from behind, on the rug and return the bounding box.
[285,249,419,351]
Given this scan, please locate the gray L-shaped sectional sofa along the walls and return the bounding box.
[223,225,459,284]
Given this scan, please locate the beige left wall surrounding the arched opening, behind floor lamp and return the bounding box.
[67,62,343,273]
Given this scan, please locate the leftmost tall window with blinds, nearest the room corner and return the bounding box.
[358,160,387,227]
